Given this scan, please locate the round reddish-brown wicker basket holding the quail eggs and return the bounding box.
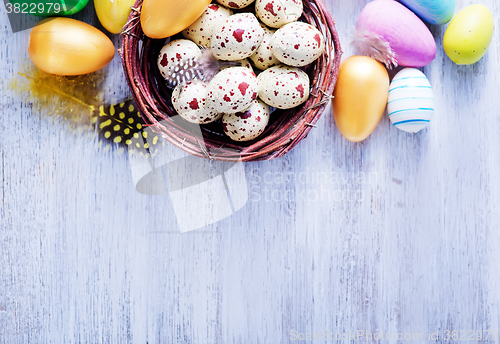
[120,0,342,161]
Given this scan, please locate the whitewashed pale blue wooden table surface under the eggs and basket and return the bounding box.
[0,0,500,344]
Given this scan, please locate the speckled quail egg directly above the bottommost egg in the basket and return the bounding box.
[207,67,259,113]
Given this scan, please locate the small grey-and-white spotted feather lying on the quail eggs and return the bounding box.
[165,48,241,88]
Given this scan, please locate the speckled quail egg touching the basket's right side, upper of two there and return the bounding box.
[271,22,326,67]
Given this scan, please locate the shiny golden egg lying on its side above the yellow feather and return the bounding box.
[28,17,115,75]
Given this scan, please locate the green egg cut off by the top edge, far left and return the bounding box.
[9,0,89,17]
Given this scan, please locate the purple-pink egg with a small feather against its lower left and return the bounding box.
[353,0,436,67]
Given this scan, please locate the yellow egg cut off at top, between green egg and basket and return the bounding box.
[94,0,139,33]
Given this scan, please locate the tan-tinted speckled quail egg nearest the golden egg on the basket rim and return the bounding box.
[182,4,233,47]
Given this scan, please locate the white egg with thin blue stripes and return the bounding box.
[387,68,434,133]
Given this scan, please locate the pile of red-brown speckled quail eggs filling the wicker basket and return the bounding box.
[158,0,325,141]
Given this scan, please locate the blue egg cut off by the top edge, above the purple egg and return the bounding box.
[400,0,455,25]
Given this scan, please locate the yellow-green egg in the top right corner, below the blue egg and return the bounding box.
[443,5,494,65]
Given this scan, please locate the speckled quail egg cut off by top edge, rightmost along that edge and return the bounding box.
[255,0,302,28]
